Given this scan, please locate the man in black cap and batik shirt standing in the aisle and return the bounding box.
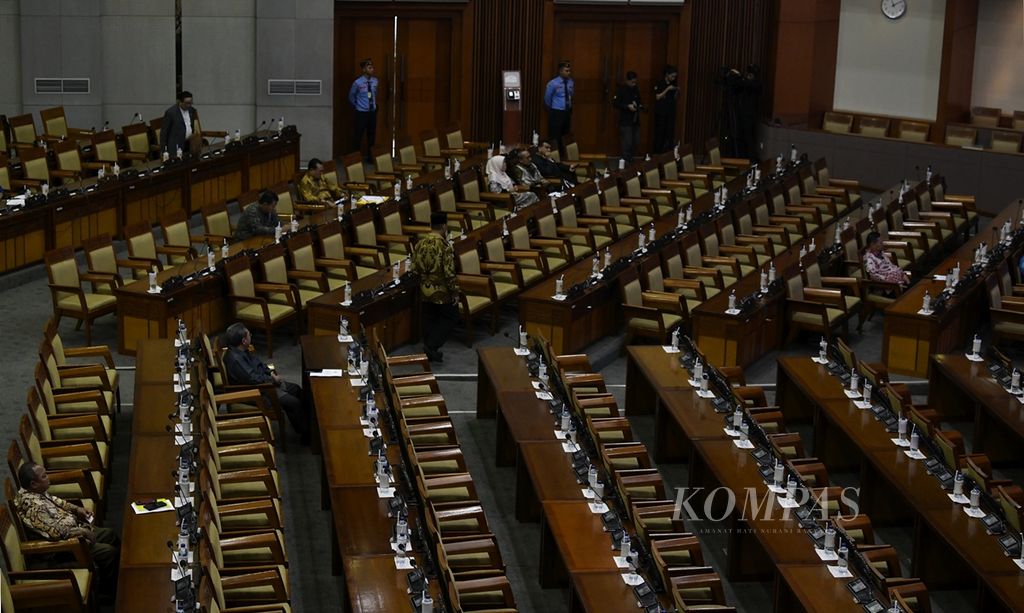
[413,212,459,362]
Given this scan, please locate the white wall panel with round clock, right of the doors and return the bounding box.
[833,0,946,121]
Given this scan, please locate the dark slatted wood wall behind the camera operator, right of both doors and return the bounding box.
[680,0,777,151]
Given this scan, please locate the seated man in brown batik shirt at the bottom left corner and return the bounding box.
[14,462,121,602]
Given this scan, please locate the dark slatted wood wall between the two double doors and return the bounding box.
[464,0,547,142]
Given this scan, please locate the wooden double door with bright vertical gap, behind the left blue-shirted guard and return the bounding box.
[334,8,462,158]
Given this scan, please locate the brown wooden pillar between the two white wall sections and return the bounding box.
[931,0,978,142]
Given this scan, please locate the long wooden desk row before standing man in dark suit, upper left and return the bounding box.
[0,138,300,274]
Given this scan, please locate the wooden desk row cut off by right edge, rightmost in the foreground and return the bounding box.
[928,353,1024,466]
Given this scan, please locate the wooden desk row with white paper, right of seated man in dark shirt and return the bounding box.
[300,336,440,613]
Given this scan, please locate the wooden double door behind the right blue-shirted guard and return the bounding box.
[551,16,678,154]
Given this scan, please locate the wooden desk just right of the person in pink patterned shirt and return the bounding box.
[882,205,1018,379]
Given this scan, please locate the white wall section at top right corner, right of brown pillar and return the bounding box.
[971,0,1024,114]
